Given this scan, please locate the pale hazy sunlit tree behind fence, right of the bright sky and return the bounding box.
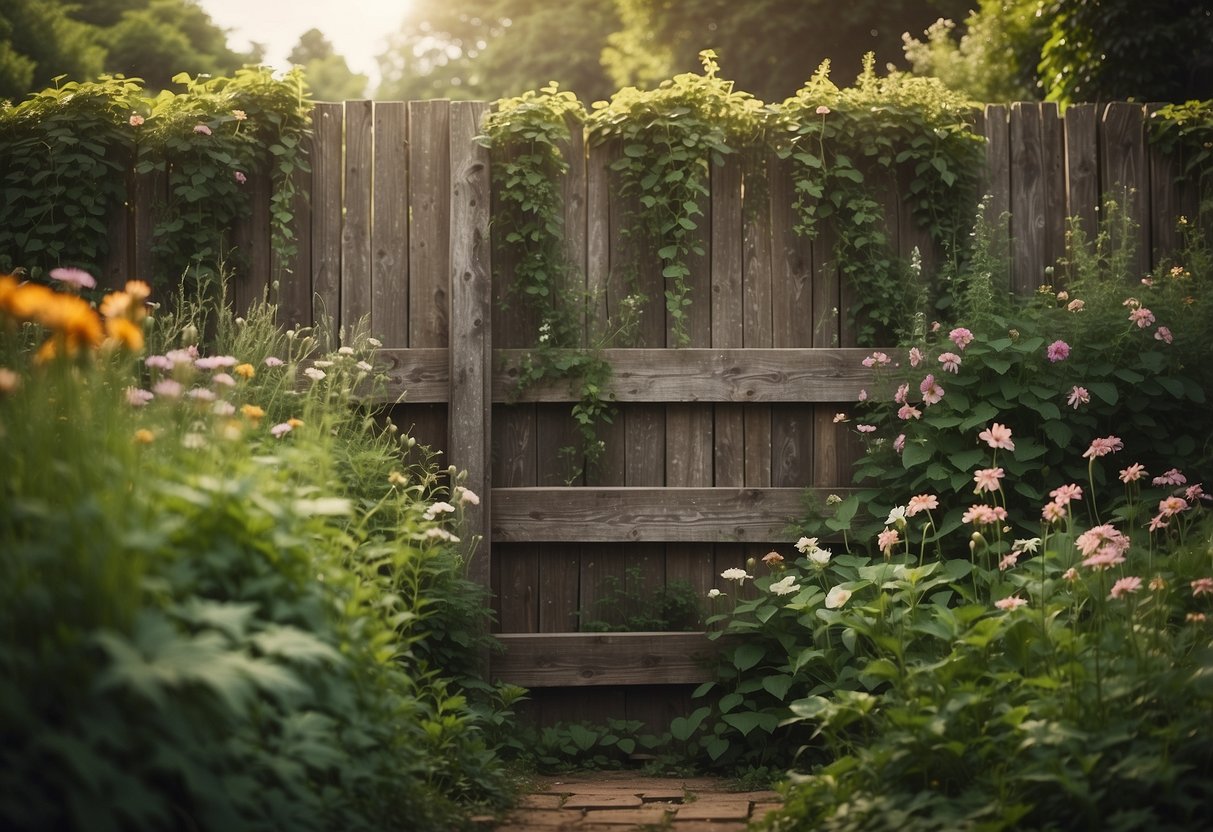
[376,0,619,101]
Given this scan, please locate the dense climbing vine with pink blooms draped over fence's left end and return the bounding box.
[0,68,311,297]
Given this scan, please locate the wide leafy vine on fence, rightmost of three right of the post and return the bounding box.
[769,55,983,344]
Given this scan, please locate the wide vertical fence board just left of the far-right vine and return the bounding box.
[1099,102,1150,279]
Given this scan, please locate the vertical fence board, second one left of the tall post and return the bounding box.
[370,101,409,347]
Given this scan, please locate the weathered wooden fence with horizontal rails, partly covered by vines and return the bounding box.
[104,101,1195,724]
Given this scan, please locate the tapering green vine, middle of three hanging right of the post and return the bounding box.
[588,50,764,347]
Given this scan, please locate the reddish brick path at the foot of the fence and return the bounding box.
[482,771,780,832]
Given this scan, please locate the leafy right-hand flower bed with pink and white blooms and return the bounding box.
[691,213,1213,830]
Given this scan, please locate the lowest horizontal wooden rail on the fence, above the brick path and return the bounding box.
[491,633,719,688]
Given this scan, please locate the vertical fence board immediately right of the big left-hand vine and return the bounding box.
[312,103,344,334]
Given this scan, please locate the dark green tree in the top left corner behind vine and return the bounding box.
[0,0,106,101]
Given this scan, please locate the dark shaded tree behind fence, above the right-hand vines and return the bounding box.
[603,0,967,101]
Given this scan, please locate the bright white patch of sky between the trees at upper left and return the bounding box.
[197,0,410,87]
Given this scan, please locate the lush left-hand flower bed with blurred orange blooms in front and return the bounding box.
[0,269,517,830]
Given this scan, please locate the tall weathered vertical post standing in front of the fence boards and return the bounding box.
[446,102,492,587]
